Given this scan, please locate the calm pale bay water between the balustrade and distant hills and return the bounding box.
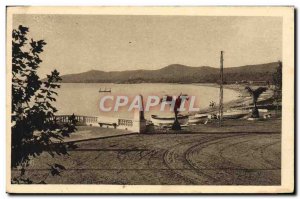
[55,83,238,118]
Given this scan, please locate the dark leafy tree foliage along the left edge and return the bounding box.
[11,25,76,183]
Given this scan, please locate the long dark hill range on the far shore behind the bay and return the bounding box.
[62,62,277,83]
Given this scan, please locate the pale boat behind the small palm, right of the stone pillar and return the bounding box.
[151,115,189,126]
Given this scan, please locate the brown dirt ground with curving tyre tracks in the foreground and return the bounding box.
[13,133,281,185]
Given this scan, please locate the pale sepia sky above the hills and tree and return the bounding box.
[13,15,282,76]
